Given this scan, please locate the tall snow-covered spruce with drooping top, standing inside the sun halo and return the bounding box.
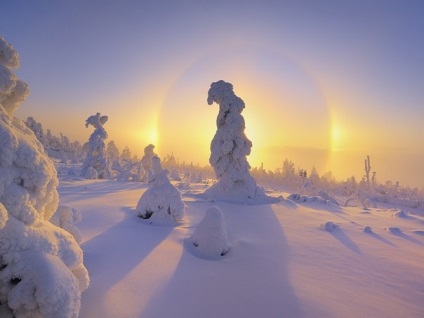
[204,80,278,204]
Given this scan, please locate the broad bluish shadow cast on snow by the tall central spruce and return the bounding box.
[143,202,303,318]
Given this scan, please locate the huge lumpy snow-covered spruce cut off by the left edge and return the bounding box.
[0,36,89,318]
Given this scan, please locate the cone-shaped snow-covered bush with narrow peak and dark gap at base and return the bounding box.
[136,156,185,224]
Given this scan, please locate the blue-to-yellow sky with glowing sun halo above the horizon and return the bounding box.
[0,0,424,186]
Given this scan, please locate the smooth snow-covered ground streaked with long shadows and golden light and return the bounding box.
[58,168,424,318]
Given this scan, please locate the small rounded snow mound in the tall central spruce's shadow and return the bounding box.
[188,206,230,260]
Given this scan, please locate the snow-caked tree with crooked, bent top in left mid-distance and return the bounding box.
[81,113,112,179]
